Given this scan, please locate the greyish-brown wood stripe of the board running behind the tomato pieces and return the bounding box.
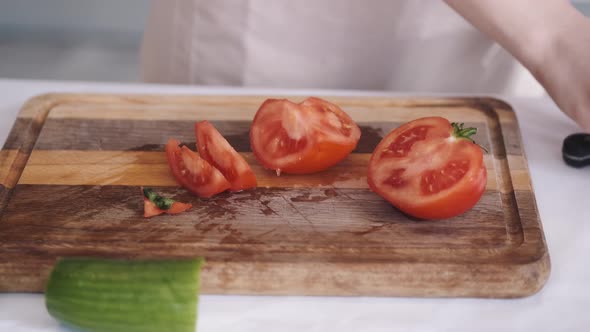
[36,117,500,155]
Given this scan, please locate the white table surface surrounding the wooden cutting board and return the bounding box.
[0,79,590,332]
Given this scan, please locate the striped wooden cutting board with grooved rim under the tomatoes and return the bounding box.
[0,94,550,297]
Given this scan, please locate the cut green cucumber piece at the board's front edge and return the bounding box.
[45,258,204,332]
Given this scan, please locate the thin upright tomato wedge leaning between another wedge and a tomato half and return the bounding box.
[195,121,256,191]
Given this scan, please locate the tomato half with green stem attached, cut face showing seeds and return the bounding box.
[367,117,487,219]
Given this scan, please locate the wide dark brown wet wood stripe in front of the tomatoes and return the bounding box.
[0,185,506,250]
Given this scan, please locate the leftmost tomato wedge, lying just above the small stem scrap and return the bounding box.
[166,139,230,197]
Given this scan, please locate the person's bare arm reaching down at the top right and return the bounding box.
[446,0,590,131]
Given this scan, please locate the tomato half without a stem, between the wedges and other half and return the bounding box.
[250,97,361,174]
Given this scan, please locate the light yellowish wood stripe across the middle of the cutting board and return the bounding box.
[18,150,530,193]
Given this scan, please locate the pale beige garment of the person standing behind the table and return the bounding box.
[142,0,534,94]
